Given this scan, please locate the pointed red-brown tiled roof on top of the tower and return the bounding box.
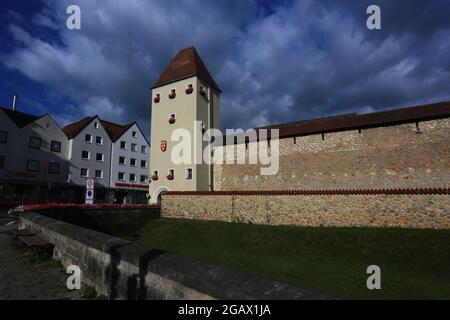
[153,47,221,91]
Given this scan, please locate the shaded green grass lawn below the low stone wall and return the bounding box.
[138,219,450,299]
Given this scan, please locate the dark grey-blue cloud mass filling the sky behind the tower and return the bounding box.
[1,0,450,132]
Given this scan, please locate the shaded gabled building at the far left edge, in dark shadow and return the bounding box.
[0,108,69,201]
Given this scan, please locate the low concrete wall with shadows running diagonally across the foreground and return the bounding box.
[20,213,327,299]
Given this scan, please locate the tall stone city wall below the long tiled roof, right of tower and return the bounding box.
[214,118,450,191]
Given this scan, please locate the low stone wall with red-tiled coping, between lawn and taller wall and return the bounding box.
[161,189,450,229]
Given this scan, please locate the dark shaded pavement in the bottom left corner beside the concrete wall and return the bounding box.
[0,226,80,300]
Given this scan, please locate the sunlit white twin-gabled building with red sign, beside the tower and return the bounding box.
[63,116,150,203]
